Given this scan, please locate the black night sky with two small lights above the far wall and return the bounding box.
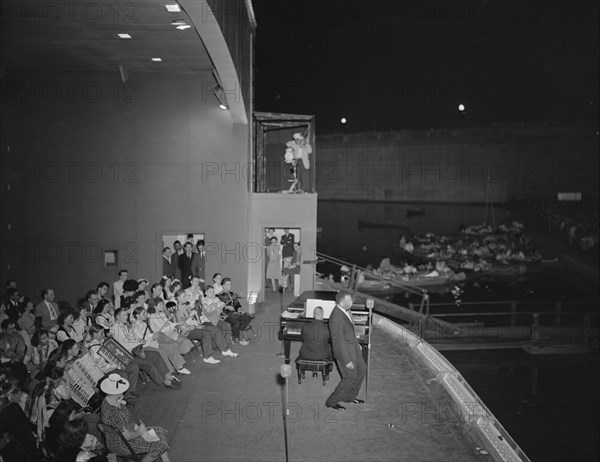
[252,0,599,133]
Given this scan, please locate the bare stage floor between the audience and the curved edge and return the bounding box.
[131,294,491,462]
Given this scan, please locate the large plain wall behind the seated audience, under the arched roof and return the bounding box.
[0,68,249,302]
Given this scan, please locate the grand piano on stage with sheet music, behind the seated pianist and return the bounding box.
[279,290,371,364]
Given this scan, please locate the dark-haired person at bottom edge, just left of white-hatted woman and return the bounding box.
[56,419,112,462]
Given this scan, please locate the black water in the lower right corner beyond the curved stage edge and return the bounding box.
[444,350,600,462]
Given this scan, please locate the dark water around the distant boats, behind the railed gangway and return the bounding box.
[317,201,599,305]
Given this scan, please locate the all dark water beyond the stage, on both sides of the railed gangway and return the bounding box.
[318,201,600,462]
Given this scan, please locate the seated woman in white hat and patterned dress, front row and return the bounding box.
[100,374,170,462]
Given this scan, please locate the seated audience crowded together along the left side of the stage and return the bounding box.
[0,270,253,461]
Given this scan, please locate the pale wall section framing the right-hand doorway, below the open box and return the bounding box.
[248,194,317,300]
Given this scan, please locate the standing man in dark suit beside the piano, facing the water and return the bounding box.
[325,291,367,410]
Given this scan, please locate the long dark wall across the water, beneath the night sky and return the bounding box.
[317,123,599,202]
